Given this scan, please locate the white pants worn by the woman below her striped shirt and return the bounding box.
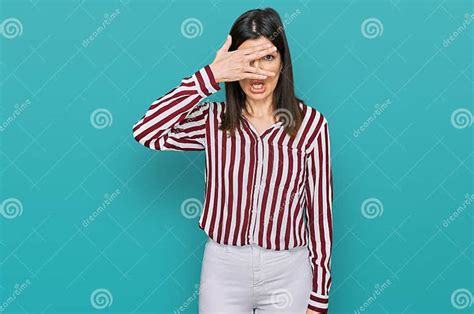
[199,238,312,314]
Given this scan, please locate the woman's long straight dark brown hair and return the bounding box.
[220,8,303,138]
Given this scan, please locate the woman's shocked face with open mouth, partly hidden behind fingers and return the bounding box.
[237,36,281,100]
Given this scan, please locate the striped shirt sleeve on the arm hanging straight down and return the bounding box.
[305,119,333,313]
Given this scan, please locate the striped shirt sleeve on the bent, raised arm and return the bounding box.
[133,65,220,150]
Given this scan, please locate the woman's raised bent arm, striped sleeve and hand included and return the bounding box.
[133,35,276,150]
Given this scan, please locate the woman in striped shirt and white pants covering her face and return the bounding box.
[133,8,333,314]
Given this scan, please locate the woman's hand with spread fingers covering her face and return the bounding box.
[210,35,277,83]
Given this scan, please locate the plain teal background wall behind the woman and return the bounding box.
[0,0,474,313]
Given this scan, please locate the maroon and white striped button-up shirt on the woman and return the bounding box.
[133,65,333,312]
